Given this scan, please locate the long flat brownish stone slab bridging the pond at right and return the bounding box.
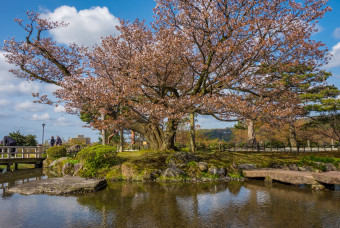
[243,169,340,185]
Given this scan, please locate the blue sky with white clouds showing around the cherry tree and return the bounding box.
[0,0,340,142]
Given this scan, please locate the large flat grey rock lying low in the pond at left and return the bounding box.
[8,176,107,195]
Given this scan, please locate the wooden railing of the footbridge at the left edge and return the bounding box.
[0,146,44,159]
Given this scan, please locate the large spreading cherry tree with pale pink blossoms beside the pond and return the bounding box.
[4,0,330,150]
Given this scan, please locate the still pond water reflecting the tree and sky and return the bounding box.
[0,169,340,228]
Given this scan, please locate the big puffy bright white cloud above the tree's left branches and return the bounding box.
[42,6,119,46]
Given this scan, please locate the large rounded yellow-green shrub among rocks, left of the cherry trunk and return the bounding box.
[77,145,117,177]
